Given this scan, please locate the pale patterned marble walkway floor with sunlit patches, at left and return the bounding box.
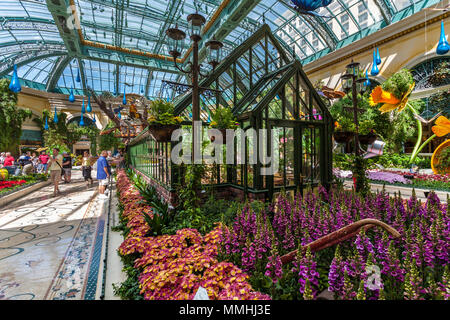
[0,171,106,300]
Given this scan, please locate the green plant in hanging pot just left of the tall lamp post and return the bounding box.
[148,99,182,142]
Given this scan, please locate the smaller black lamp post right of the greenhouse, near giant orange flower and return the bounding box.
[341,60,367,156]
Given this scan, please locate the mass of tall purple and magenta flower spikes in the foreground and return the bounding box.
[221,187,450,299]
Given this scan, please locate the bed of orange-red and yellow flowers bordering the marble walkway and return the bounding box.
[117,170,270,300]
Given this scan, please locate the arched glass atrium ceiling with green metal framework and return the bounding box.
[0,0,439,98]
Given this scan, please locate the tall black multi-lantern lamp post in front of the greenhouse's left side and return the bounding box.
[166,13,223,160]
